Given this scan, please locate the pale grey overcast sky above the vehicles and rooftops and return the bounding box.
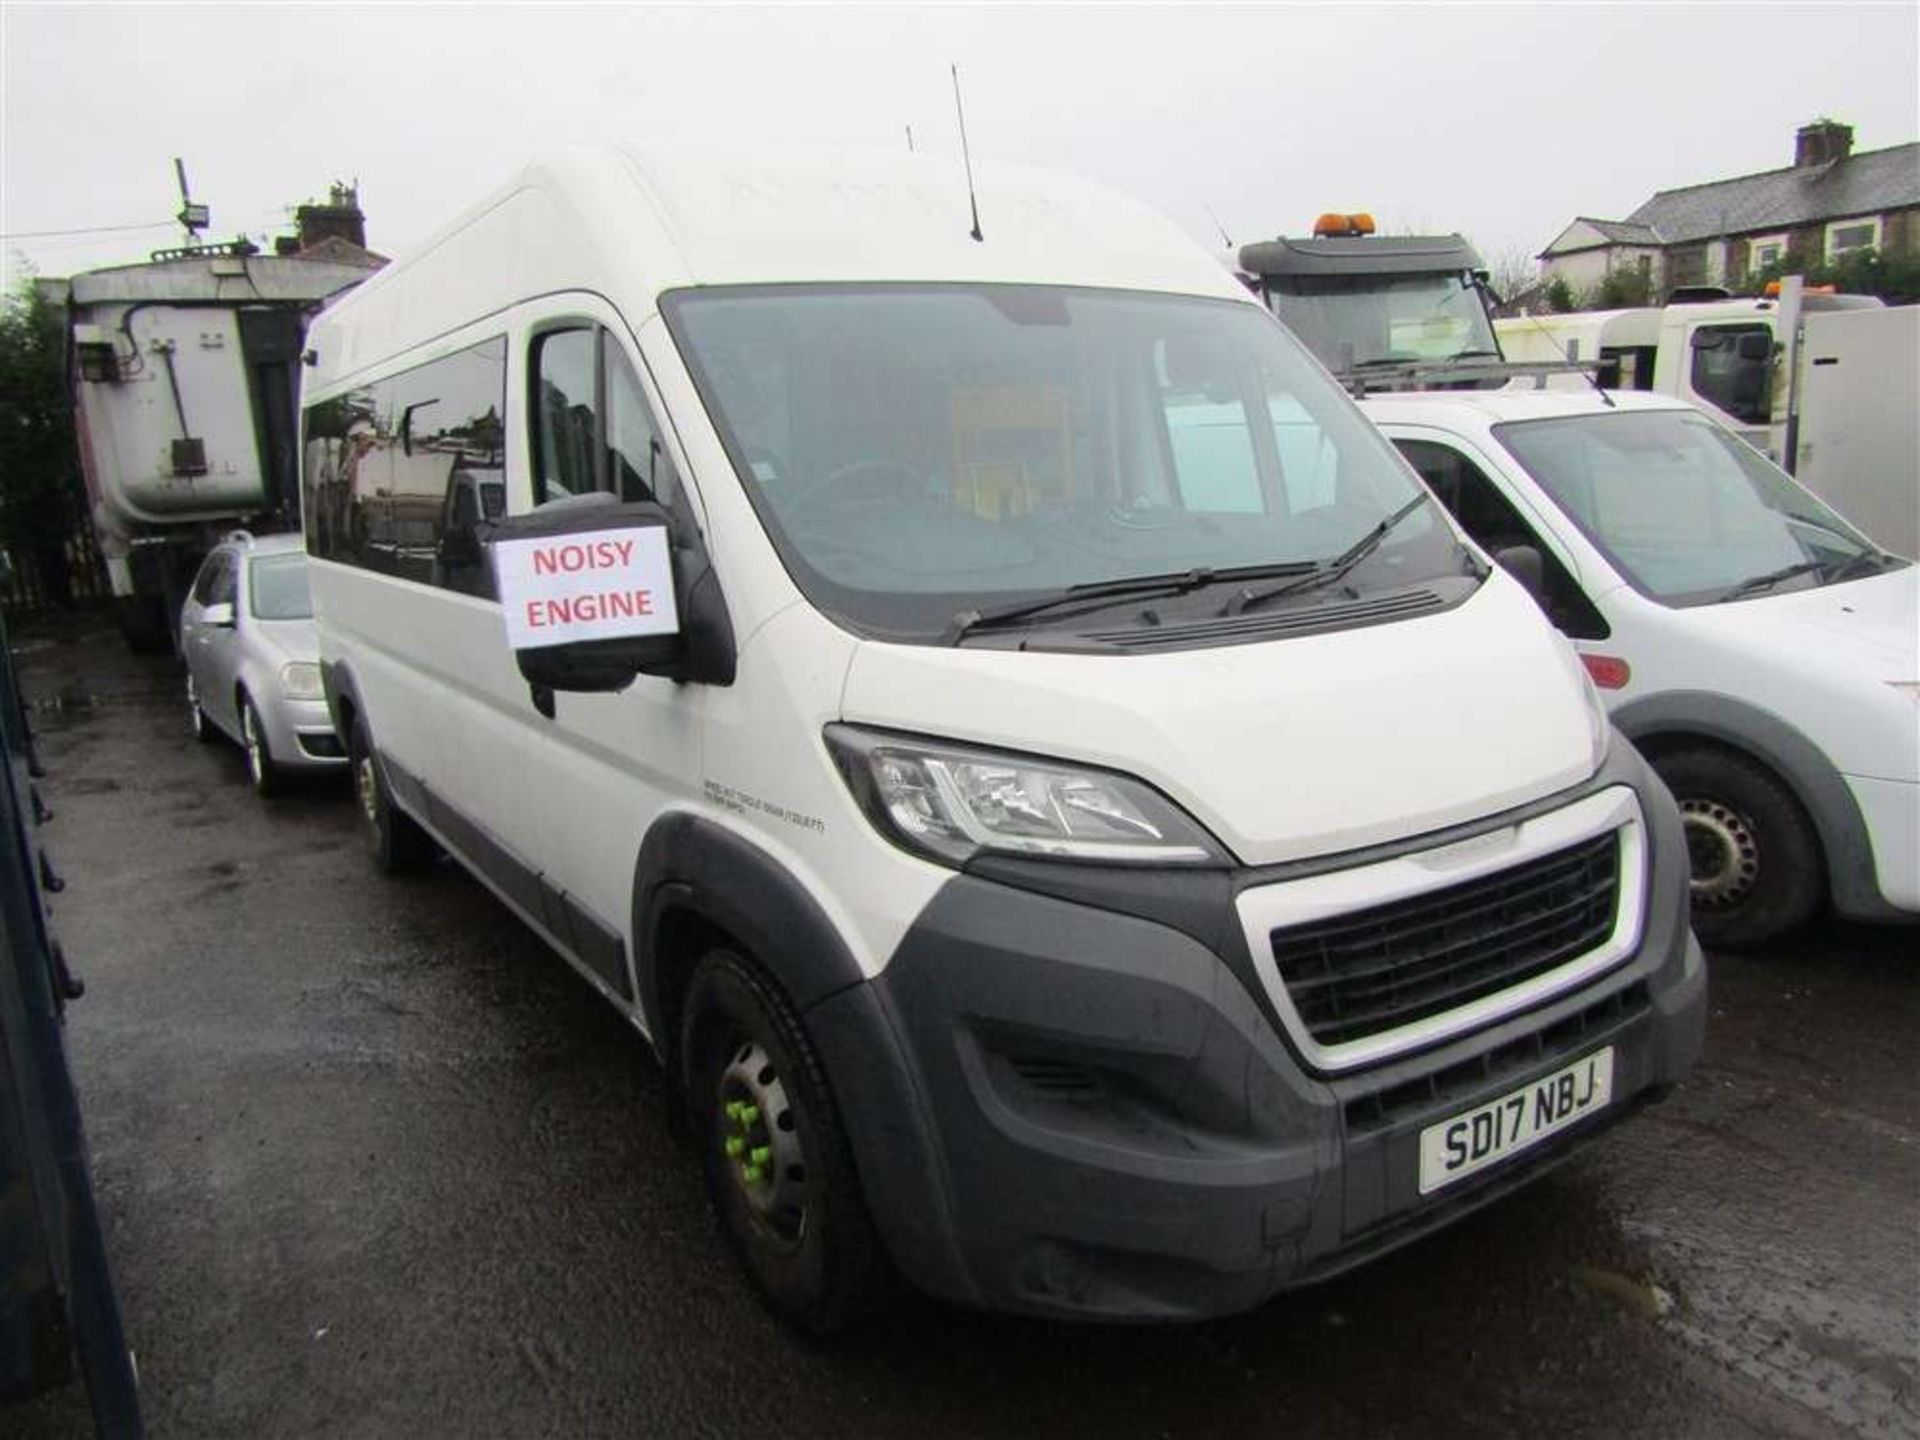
[0,0,1920,284]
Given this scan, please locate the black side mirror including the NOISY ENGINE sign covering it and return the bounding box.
[484,495,733,703]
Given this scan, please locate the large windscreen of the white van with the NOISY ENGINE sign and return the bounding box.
[662,286,1461,641]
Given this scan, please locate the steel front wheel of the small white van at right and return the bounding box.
[1653,749,1826,948]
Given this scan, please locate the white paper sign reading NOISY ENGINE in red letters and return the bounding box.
[493,526,680,651]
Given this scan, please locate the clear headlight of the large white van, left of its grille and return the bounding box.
[826,726,1227,866]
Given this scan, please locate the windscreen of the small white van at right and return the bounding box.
[1494,409,1882,605]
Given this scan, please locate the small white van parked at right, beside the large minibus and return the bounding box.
[1361,390,1920,947]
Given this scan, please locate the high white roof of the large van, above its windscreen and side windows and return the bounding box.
[315,144,1256,384]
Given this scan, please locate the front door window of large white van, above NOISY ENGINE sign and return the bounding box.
[532,326,680,505]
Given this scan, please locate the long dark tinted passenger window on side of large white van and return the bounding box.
[303,336,507,597]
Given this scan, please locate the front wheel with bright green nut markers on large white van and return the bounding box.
[680,950,887,1336]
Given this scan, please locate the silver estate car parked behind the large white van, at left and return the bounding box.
[180,530,346,795]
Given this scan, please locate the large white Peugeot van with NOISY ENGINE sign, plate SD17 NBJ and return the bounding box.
[291,148,1705,1332]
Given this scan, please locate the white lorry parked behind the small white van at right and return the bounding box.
[1494,280,1920,559]
